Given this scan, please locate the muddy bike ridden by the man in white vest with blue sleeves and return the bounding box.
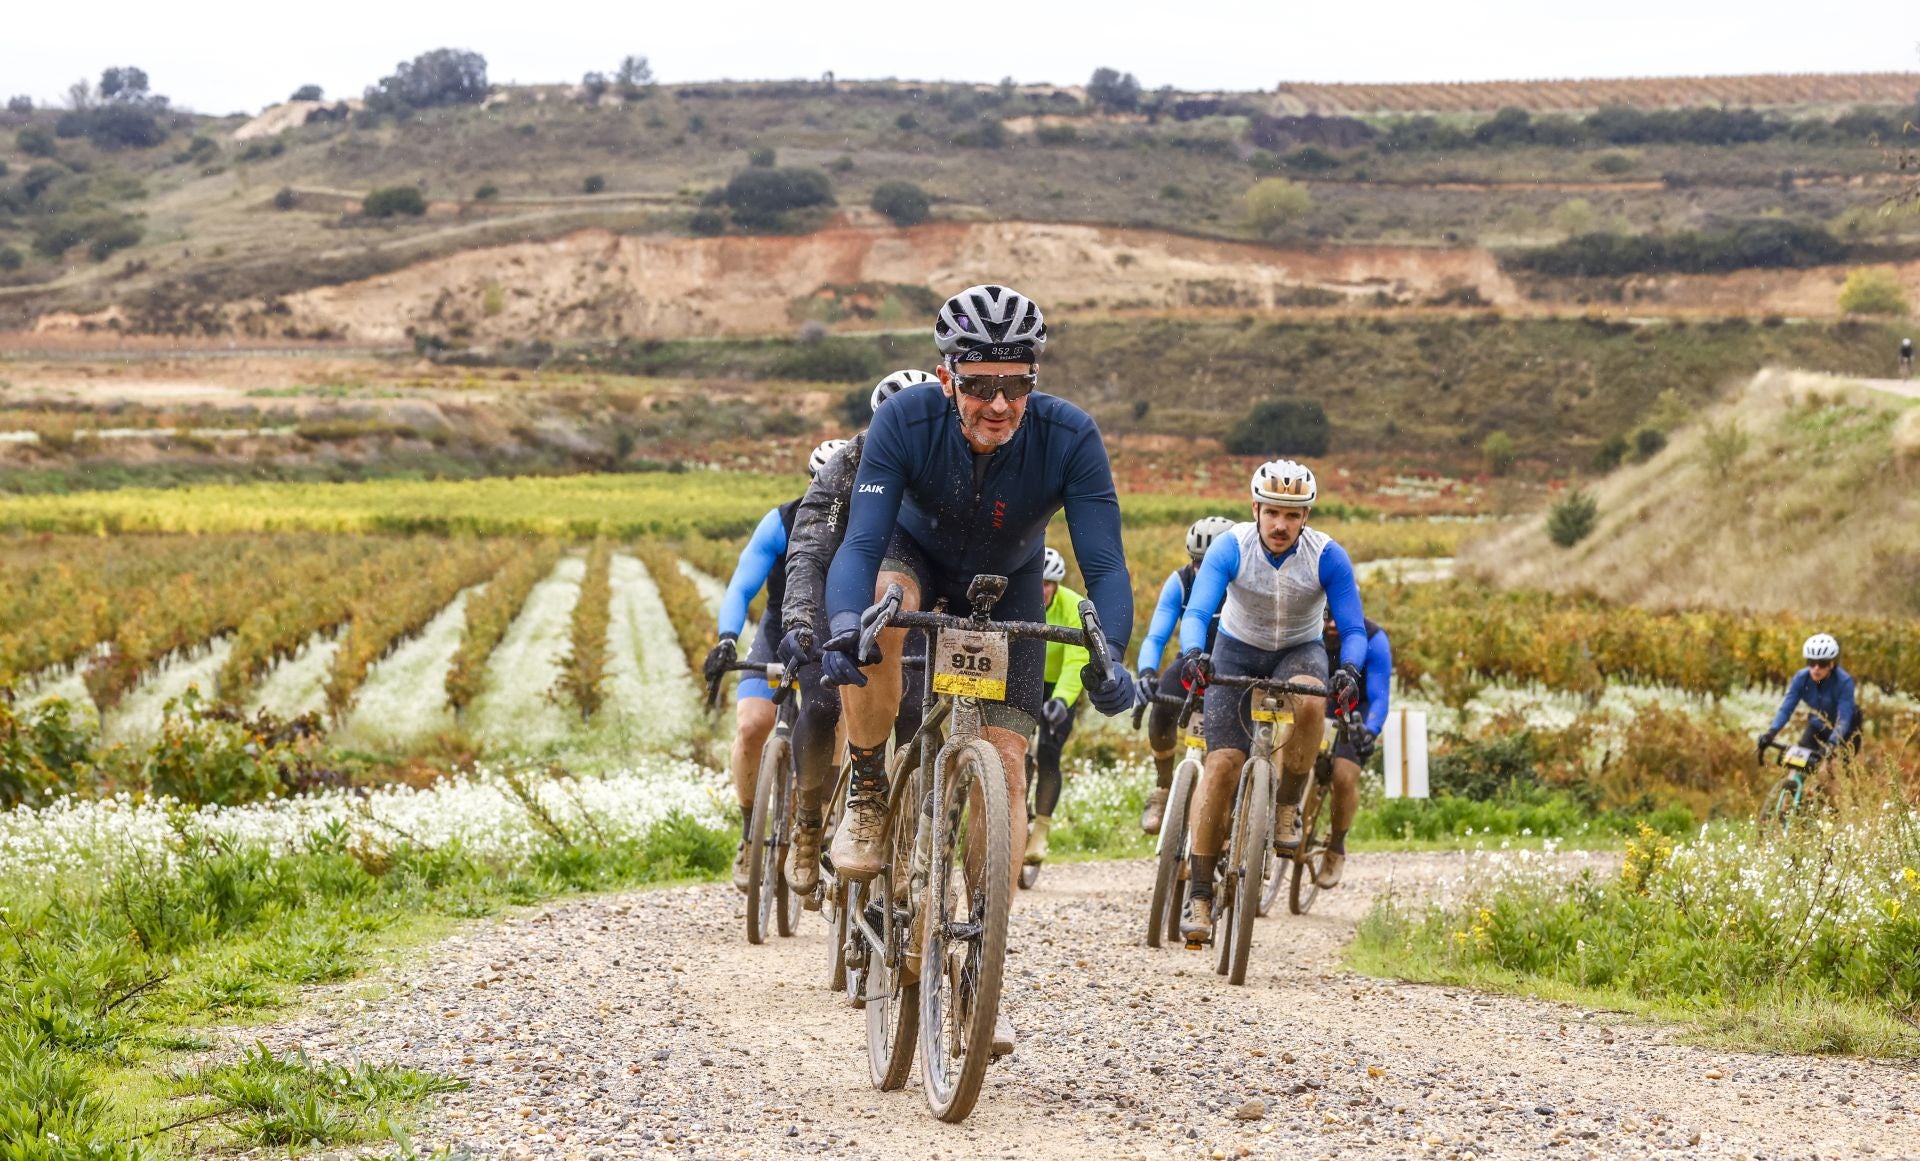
[1169,674,1327,984]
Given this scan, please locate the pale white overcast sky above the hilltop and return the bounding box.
[0,0,1920,113]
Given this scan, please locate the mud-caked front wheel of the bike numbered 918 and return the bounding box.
[920,737,1014,1125]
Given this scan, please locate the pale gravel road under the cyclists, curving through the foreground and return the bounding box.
[250,854,1920,1161]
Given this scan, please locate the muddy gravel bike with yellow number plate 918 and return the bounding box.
[847,574,1112,1123]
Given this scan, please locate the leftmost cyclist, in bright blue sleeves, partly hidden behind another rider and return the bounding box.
[701,439,847,890]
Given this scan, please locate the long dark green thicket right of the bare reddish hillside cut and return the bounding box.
[1503,219,1847,278]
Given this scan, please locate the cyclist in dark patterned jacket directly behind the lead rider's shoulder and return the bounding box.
[778,370,935,894]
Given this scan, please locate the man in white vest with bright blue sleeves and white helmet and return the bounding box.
[1181,459,1367,944]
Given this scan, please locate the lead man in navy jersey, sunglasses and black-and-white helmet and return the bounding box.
[822,284,1133,1052]
